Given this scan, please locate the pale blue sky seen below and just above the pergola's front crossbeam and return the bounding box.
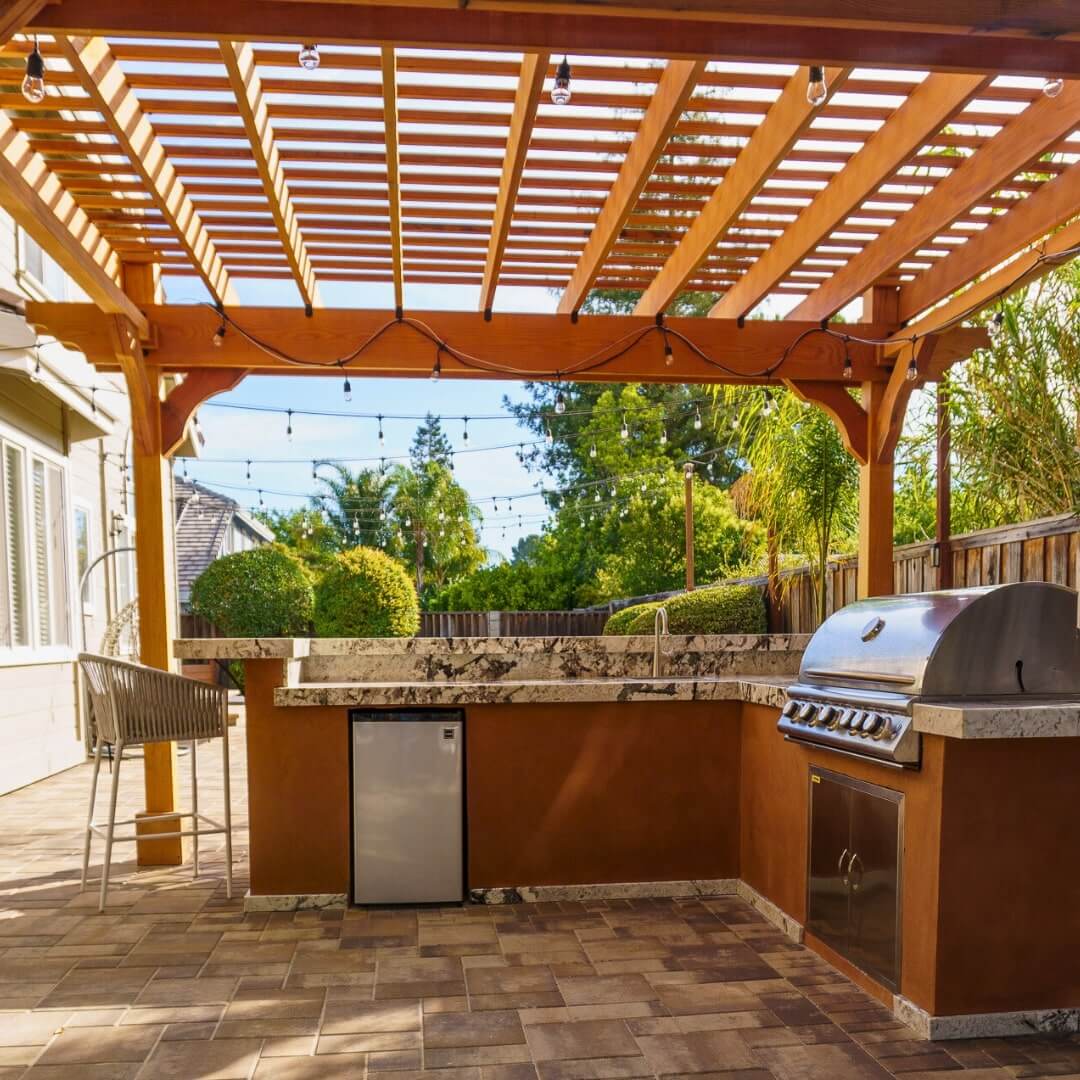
[165,278,556,558]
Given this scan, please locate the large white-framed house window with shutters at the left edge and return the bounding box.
[0,441,71,649]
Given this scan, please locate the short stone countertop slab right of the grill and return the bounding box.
[912,699,1080,739]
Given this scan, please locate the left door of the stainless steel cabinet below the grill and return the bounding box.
[807,771,851,954]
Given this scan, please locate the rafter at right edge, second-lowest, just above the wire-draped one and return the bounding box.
[899,157,1080,323]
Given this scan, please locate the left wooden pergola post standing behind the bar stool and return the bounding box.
[123,264,184,866]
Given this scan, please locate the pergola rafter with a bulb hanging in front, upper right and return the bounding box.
[634,68,851,315]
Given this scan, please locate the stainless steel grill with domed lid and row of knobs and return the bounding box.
[779,581,1080,768]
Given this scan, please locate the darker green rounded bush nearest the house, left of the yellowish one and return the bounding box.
[191,544,312,637]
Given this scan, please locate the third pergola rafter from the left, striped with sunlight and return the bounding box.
[220,41,319,307]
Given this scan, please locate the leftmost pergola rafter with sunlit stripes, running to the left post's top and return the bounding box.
[0,112,148,337]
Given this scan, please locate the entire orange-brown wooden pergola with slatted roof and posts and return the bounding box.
[0,0,1080,862]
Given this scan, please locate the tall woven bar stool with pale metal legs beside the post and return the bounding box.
[79,652,232,912]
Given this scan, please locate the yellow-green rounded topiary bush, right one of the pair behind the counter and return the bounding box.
[315,548,420,637]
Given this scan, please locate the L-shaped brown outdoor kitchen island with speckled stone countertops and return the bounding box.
[176,636,1080,1038]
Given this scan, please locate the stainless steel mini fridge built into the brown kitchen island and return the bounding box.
[349,710,464,904]
